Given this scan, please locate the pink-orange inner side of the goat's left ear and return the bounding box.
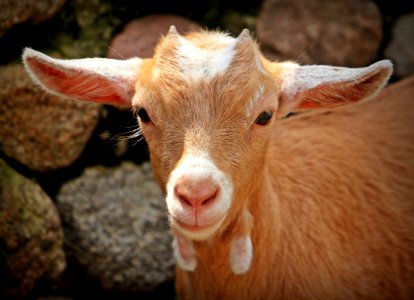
[27,57,126,105]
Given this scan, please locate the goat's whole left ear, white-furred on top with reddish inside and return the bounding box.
[23,48,142,105]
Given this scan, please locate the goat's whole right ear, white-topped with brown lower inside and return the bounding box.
[278,60,392,116]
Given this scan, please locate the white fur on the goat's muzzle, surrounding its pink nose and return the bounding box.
[166,153,233,240]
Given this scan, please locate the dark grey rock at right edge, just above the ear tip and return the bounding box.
[385,13,414,77]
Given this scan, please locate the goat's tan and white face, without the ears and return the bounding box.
[133,29,278,240]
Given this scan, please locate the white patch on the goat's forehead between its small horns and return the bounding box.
[176,36,237,82]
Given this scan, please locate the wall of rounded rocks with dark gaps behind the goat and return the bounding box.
[0,0,414,300]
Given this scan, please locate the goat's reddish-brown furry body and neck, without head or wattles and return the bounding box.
[177,78,414,299]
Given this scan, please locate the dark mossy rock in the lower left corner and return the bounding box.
[0,160,66,299]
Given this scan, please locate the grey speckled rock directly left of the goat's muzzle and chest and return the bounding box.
[57,162,175,292]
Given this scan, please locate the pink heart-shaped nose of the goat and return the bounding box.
[174,177,219,207]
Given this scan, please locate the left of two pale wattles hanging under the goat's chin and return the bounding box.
[172,236,197,271]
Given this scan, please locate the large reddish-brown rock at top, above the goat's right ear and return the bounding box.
[256,0,382,67]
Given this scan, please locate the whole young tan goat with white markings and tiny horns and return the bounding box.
[23,26,414,299]
